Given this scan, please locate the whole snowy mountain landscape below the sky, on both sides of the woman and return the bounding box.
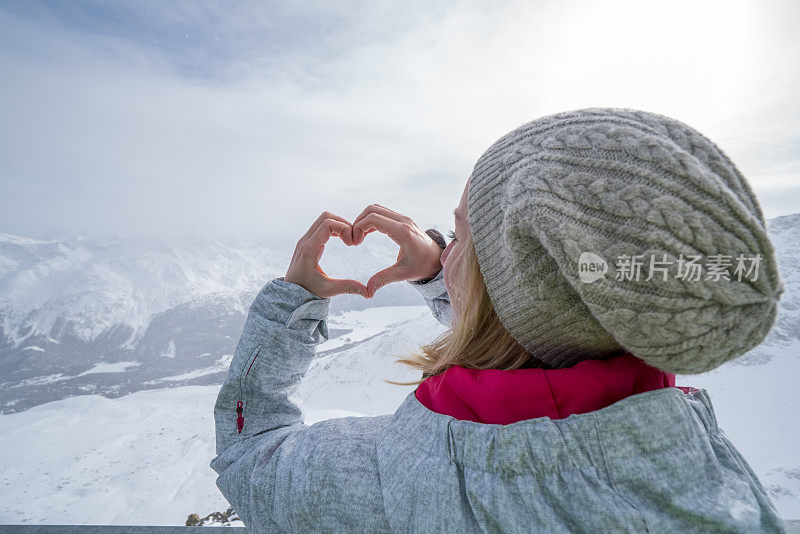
[0,214,800,525]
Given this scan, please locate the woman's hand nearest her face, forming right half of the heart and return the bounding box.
[352,204,442,298]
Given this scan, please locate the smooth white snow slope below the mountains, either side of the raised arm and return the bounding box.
[0,306,444,525]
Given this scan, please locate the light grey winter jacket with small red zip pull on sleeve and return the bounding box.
[211,273,784,533]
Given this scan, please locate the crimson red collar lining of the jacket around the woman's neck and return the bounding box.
[415,353,675,425]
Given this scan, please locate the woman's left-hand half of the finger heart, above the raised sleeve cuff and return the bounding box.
[283,211,368,298]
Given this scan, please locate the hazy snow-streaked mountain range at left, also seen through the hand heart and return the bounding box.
[0,234,419,413]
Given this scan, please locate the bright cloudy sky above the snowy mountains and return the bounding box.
[0,0,800,247]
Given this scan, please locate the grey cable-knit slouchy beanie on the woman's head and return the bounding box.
[468,108,785,374]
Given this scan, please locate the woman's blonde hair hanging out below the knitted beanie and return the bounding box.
[384,232,548,386]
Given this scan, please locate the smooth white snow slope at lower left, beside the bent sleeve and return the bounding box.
[0,386,366,526]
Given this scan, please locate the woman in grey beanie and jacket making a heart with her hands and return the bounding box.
[211,108,784,532]
